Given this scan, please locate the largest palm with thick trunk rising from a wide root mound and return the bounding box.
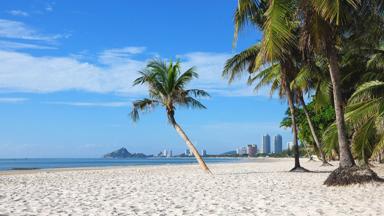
[299,0,382,185]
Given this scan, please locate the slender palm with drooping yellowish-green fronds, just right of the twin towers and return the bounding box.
[230,0,305,171]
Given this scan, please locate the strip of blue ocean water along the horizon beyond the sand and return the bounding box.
[0,157,242,170]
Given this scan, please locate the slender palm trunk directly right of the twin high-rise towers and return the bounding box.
[281,67,301,171]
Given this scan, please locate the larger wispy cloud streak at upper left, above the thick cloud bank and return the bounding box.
[0,19,63,42]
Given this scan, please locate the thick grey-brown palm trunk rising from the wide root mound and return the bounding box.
[328,48,355,168]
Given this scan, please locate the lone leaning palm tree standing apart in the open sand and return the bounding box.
[131,59,211,173]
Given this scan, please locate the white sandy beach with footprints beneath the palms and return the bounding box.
[0,159,384,216]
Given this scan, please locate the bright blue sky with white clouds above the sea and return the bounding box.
[0,0,291,158]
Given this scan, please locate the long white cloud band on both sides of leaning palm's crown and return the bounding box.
[0,47,264,97]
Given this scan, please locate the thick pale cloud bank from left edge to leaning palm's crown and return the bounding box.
[0,51,145,93]
